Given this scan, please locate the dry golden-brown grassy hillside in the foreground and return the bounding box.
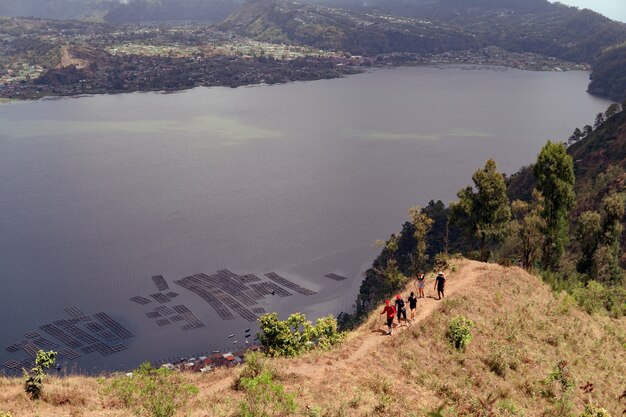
[0,260,626,417]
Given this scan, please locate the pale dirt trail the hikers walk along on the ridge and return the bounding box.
[207,260,488,392]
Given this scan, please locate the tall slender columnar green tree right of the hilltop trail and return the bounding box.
[533,141,575,270]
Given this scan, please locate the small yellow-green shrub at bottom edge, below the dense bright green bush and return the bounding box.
[239,370,297,417]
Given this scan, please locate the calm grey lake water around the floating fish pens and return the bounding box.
[0,67,608,371]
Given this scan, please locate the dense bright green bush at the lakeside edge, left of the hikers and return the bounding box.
[259,313,345,356]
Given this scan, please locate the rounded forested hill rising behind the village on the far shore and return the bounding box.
[219,0,478,55]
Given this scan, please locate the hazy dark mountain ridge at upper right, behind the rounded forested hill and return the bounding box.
[306,0,626,63]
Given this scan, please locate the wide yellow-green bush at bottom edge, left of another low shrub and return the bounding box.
[103,362,198,417]
